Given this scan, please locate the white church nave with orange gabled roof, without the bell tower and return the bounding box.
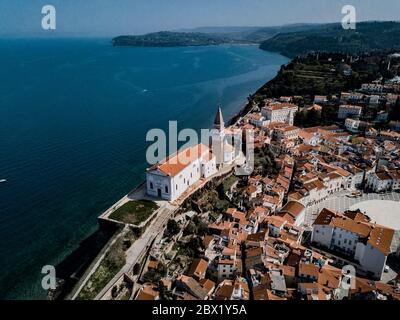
[146,144,217,201]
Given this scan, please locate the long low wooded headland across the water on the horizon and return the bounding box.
[112,31,244,47]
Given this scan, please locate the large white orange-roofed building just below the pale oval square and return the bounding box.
[311,209,394,279]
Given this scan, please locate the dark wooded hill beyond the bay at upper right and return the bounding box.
[260,22,400,57]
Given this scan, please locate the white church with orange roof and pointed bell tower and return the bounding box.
[146,108,241,202]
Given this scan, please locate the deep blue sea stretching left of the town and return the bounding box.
[0,39,288,299]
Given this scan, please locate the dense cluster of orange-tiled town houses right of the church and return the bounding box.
[136,52,400,300]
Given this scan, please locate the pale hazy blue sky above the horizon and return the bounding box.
[0,0,400,36]
